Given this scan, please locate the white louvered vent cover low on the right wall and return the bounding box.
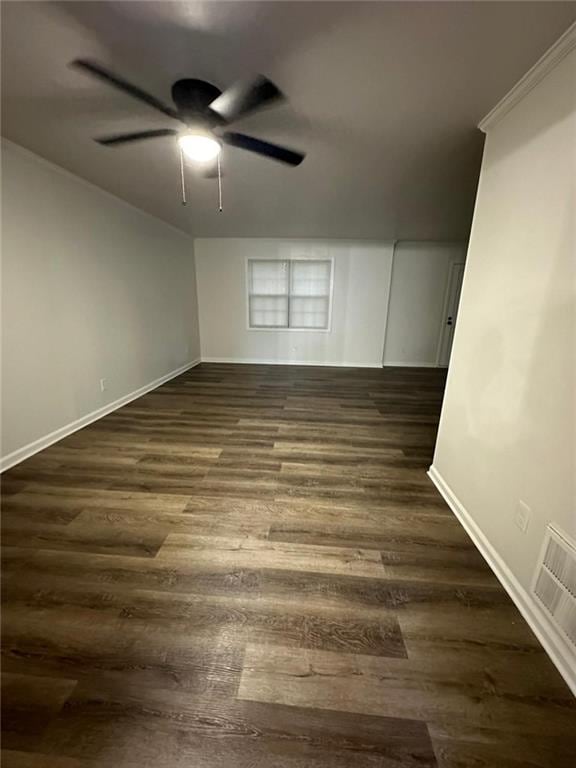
[533,525,576,650]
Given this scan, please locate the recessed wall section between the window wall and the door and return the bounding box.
[384,241,466,366]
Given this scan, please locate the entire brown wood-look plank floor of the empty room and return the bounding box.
[2,364,576,768]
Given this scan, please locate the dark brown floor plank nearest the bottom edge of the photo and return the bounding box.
[42,681,435,768]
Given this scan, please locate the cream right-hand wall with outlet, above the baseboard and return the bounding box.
[433,40,576,690]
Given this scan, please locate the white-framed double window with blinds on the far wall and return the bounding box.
[248,259,332,331]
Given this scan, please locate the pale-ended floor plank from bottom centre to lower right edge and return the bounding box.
[238,644,575,746]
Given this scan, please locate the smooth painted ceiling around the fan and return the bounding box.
[2,0,576,240]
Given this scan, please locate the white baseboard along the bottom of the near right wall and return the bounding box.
[428,465,576,696]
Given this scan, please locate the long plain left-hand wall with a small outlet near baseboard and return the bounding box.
[2,142,199,463]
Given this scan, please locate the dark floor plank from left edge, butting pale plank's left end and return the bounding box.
[3,604,243,695]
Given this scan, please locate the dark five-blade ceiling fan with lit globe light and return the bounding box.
[71,59,305,171]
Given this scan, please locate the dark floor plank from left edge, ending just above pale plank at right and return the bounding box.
[3,575,406,657]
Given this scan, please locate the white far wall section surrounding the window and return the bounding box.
[195,238,392,367]
